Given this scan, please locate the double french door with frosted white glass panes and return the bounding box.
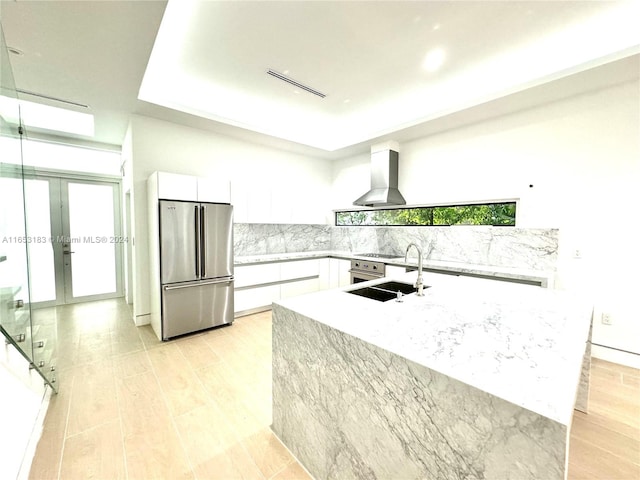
[25,176,126,307]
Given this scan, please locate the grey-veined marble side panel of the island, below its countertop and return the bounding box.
[272,305,568,480]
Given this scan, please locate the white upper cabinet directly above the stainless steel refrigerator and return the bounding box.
[150,172,231,203]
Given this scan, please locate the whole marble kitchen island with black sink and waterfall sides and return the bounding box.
[272,273,592,480]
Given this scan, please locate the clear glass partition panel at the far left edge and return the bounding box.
[0,24,57,391]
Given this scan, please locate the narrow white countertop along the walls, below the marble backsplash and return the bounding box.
[234,250,555,287]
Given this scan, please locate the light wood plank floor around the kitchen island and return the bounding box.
[30,299,640,480]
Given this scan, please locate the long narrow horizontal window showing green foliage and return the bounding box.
[336,202,516,226]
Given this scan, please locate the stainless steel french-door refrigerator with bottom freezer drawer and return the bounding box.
[159,200,233,340]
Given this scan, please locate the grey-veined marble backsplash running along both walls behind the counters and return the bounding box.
[234,223,558,271]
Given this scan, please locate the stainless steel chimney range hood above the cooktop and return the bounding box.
[353,142,407,207]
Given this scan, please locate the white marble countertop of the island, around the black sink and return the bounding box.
[278,272,592,425]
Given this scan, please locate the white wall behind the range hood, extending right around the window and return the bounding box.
[332,81,640,361]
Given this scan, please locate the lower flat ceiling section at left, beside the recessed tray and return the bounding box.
[0,0,166,145]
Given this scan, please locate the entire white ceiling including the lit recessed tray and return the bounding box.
[0,0,640,156]
